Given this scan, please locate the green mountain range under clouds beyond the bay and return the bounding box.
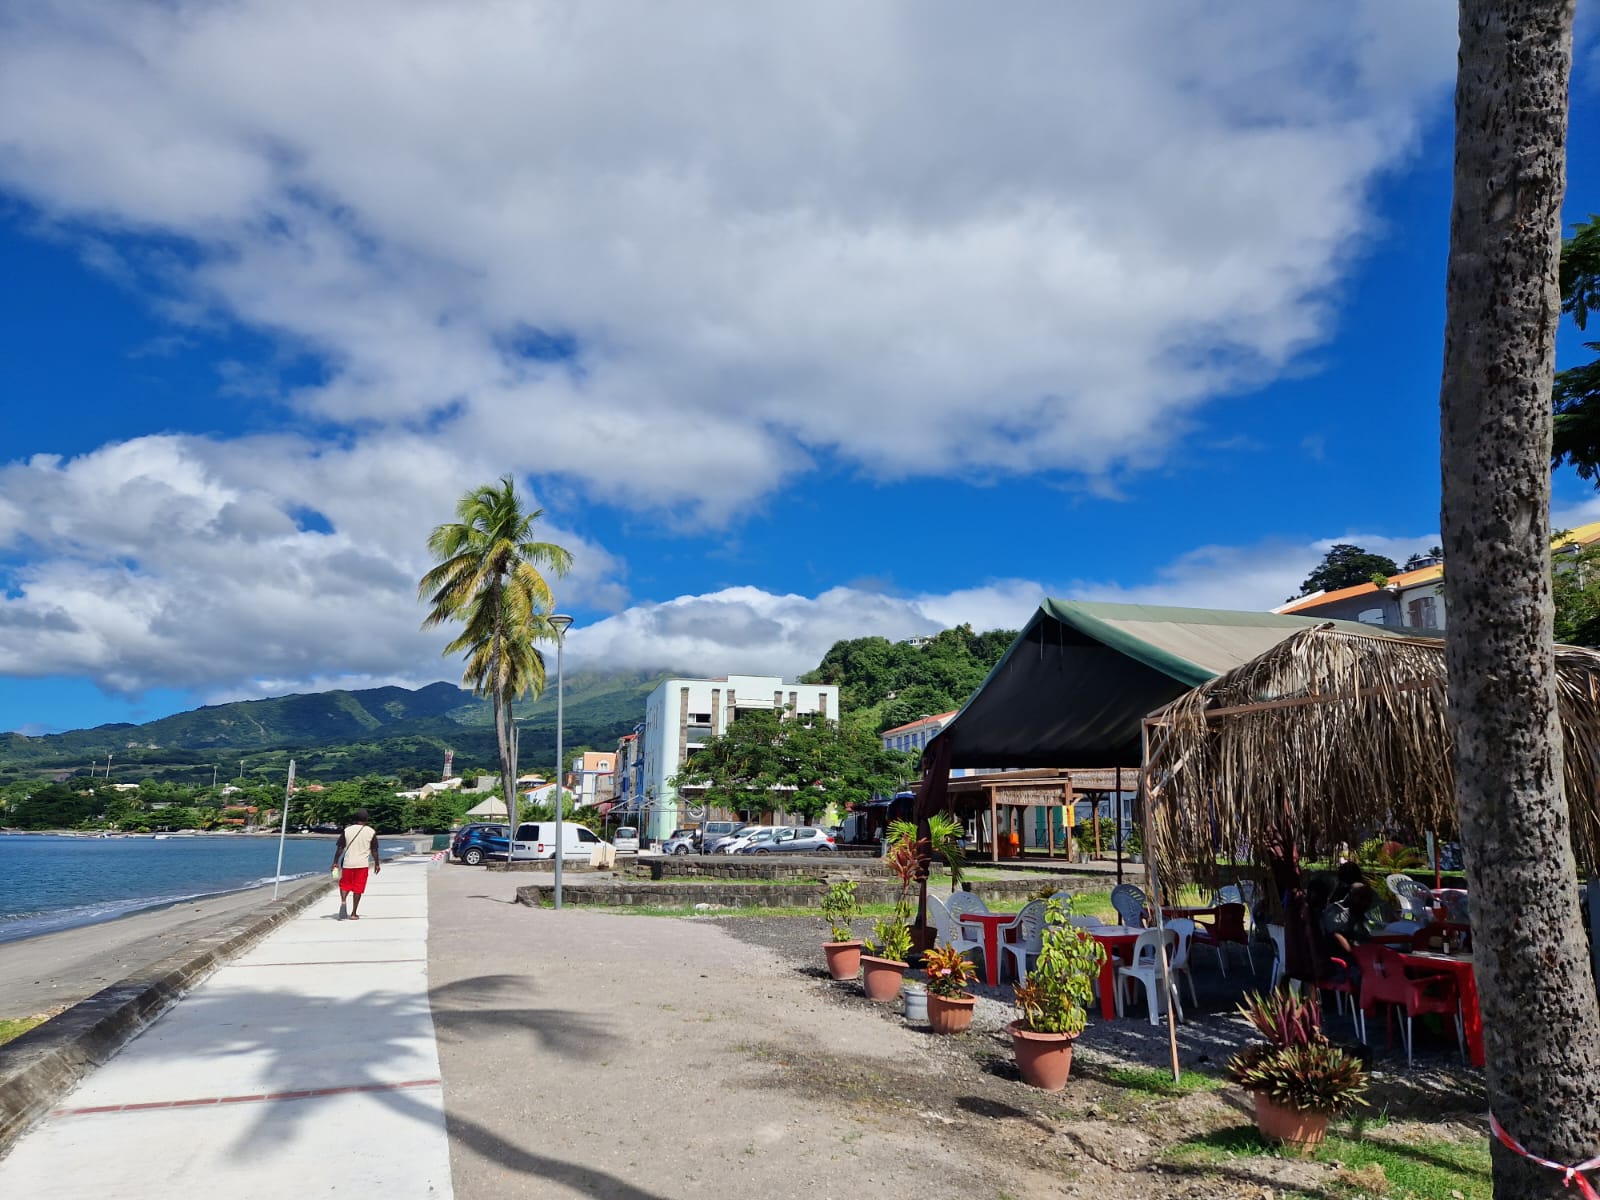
[0,670,666,784]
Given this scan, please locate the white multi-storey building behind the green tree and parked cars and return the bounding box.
[642,675,838,838]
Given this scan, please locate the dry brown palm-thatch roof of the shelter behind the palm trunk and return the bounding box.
[1149,626,1600,877]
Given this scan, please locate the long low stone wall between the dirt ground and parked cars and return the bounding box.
[517,877,1102,909]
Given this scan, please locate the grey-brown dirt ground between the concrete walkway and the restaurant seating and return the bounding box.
[429,867,1474,1200]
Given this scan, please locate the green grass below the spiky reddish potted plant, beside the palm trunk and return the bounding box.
[1163,1125,1494,1200]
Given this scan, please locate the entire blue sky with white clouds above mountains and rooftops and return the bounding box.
[0,0,1600,731]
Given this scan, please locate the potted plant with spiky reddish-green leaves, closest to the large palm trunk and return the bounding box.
[1227,987,1366,1154]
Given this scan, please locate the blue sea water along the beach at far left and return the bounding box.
[0,834,400,942]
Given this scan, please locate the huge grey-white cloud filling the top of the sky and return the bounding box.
[0,0,1454,515]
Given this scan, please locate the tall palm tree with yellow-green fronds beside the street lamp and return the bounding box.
[418,475,573,834]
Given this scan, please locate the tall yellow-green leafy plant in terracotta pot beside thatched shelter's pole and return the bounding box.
[1010,899,1106,1091]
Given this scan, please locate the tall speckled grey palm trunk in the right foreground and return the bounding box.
[1440,0,1600,1200]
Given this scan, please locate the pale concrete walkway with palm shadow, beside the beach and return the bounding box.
[0,859,453,1200]
